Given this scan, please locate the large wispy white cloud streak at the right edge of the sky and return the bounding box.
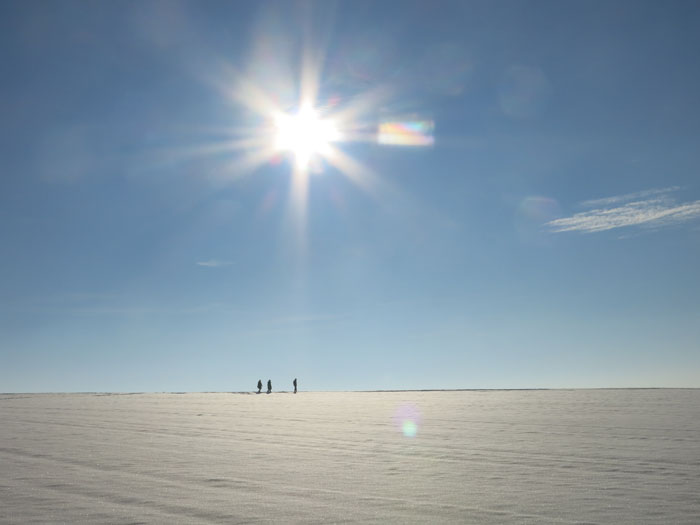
[547,186,700,233]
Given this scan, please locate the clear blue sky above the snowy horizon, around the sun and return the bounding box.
[0,1,700,392]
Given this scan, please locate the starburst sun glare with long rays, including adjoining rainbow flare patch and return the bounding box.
[200,40,434,247]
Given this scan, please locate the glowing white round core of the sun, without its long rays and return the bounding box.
[274,104,341,170]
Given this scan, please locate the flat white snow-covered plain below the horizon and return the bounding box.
[0,390,700,524]
